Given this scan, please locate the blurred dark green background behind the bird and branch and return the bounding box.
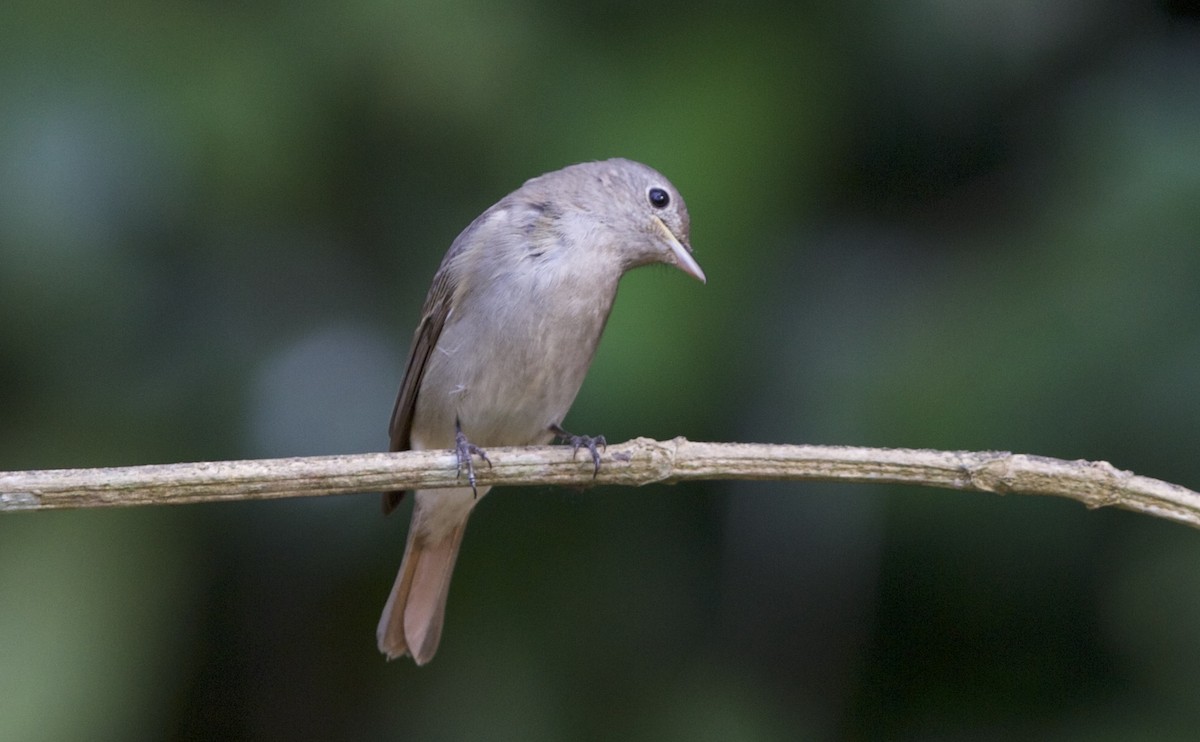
[0,0,1200,741]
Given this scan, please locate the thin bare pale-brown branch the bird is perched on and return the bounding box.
[0,438,1200,527]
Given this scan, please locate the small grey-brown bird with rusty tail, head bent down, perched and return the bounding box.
[376,160,704,665]
